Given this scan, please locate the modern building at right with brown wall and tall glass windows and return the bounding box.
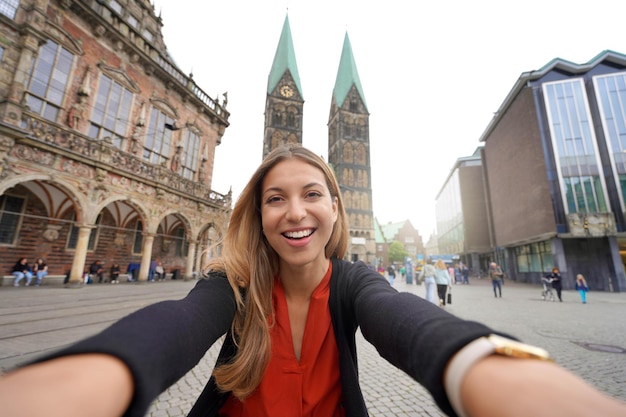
[472,51,626,291]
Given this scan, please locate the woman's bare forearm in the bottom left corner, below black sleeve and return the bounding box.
[0,354,133,417]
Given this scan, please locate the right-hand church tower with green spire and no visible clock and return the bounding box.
[328,33,376,264]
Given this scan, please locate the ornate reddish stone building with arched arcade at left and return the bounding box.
[0,0,231,283]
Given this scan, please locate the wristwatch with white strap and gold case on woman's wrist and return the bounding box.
[444,334,552,417]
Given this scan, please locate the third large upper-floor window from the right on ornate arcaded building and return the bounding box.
[89,74,133,148]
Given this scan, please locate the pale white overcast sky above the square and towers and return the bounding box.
[153,0,626,240]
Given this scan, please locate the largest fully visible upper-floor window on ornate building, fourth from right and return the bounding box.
[26,40,74,121]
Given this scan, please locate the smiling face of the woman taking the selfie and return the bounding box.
[261,159,338,268]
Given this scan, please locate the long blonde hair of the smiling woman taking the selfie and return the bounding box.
[205,144,348,399]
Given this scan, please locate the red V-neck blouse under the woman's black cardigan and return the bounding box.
[219,263,345,417]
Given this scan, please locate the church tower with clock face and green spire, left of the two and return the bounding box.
[263,16,304,158]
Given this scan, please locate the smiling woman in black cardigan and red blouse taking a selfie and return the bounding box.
[0,144,626,417]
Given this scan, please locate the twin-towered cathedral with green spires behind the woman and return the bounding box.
[263,16,376,264]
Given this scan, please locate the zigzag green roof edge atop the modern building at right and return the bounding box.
[479,49,626,142]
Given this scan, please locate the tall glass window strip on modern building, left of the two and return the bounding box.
[543,79,607,213]
